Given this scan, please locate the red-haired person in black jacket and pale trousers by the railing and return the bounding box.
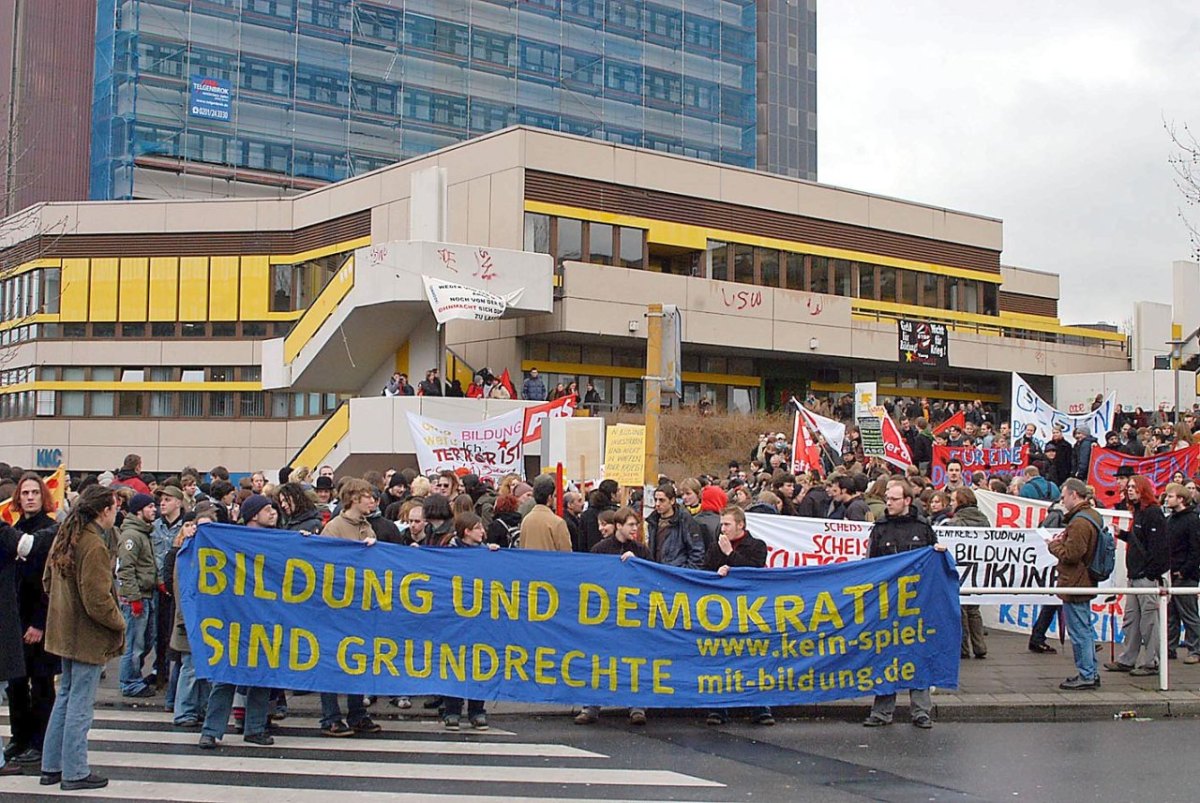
[1104,474,1171,676]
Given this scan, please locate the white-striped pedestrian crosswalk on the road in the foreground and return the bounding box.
[0,709,724,803]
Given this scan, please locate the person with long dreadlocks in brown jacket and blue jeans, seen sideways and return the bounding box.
[41,485,125,791]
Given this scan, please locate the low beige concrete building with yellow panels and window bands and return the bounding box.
[0,127,1128,471]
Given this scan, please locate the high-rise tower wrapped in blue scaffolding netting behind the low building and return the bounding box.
[89,0,816,199]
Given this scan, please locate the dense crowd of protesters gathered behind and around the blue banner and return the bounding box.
[0,371,1200,790]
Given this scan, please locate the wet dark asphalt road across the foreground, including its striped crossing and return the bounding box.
[0,709,1198,803]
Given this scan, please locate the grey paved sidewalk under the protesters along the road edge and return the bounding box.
[96,631,1200,726]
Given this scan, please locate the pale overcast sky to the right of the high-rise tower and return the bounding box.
[817,0,1200,323]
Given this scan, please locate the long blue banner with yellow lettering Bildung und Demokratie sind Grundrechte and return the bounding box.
[179,525,960,708]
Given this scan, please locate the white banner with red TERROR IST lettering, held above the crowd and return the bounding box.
[406,408,524,480]
